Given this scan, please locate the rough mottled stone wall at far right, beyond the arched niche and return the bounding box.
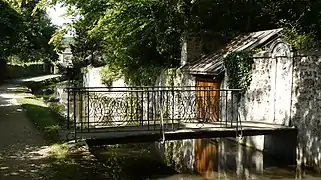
[291,53,321,170]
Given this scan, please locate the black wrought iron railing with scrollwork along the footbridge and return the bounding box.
[67,86,240,132]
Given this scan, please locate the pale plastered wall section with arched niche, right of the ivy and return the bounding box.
[221,46,296,156]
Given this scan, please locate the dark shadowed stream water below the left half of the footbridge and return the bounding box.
[87,143,204,180]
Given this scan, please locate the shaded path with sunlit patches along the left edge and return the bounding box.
[0,85,48,180]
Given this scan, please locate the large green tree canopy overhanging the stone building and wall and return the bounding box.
[44,0,321,84]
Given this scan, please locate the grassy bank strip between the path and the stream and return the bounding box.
[17,90,112,180]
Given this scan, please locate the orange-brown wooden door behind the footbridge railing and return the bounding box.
[196,78,221,122]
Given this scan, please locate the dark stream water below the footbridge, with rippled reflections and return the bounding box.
[91,138,321,180]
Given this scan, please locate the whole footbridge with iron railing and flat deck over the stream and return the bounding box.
[63,86,293,144]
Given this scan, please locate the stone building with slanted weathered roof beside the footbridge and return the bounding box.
[158,29,321,173]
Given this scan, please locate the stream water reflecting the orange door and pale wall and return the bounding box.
[195,138,321,180]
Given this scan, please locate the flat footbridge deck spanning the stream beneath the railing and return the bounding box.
[63,121,296,144]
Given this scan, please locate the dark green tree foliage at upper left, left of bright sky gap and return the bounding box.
[13,0,58,61]
